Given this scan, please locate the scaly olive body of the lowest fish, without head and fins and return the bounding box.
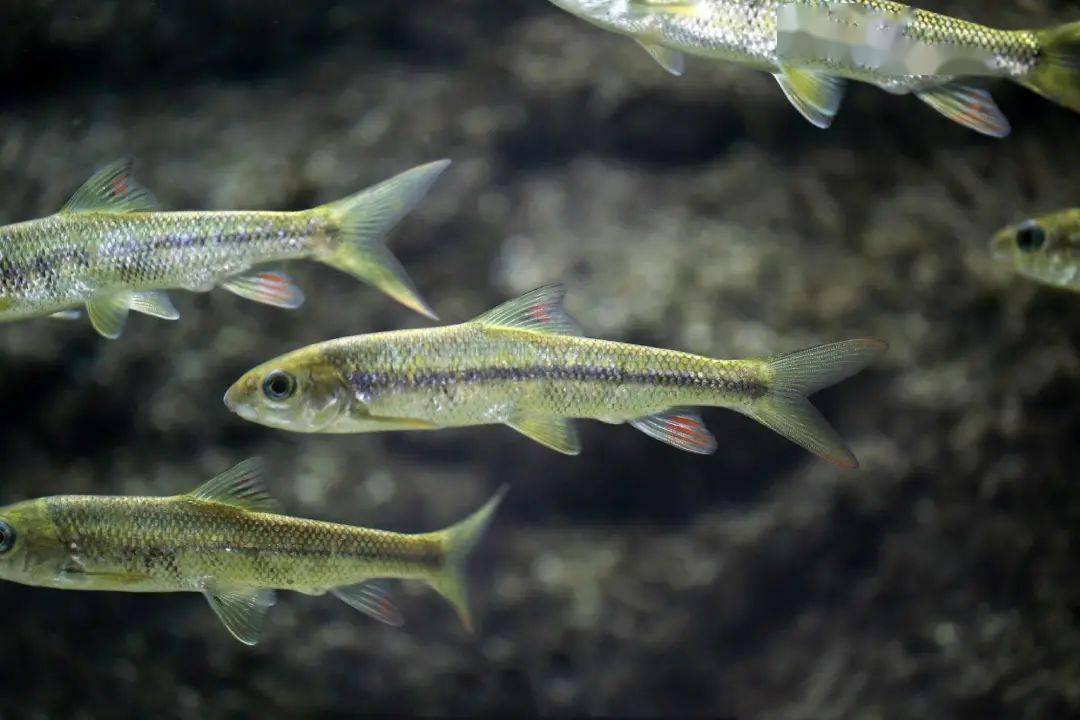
[45,495,444,593]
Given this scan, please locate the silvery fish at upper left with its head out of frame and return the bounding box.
[0,158,449,339]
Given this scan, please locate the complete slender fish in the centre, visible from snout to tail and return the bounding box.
[225,284,886,468]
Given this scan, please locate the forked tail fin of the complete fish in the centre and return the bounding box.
[748,338,888,468]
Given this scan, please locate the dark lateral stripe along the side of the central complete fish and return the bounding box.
[349,365,766,397]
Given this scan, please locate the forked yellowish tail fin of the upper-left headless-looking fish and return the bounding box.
[321,160,450,320]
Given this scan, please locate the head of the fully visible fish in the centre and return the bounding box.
[225,345,348,433]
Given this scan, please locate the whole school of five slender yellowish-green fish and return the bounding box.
[0,0,1080,644]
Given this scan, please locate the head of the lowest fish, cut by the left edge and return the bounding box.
[0,500,65,585]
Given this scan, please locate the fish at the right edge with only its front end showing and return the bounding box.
[993,208,1080,293]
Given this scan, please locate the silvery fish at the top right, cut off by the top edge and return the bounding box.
[551,0,1080,137]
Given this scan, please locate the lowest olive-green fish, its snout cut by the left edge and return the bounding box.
[0,458,507,646]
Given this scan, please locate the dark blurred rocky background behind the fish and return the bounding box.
[0,0,1080,719]
